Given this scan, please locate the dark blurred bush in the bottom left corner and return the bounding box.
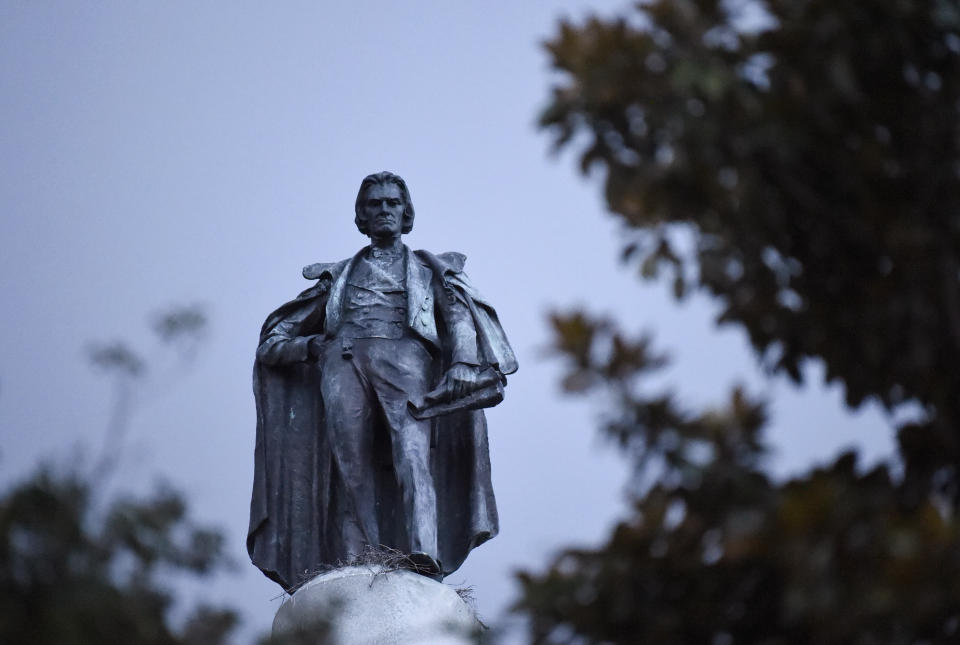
[0,469,237,645]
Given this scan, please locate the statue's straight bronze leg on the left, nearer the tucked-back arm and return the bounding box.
[321,343,380,555]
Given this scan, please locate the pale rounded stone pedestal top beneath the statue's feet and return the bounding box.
[273,566,480,645]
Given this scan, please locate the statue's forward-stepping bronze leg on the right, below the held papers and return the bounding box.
[371,338,439,560]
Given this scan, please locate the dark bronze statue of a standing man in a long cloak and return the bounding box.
[247,172,517,590]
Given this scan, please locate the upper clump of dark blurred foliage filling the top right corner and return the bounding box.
[541,0,960,496]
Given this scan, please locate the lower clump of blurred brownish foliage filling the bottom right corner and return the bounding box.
[517,313,960,645]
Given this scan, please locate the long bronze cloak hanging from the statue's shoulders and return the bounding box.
[247,251,517,591]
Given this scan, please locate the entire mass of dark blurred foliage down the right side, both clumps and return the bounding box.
[517,0,960,644]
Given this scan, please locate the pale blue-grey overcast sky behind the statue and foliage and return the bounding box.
[0,0,892,633]
